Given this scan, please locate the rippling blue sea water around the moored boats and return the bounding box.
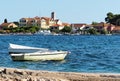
[0,35,120,73]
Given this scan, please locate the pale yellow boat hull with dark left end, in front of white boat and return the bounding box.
[11,53,67,61]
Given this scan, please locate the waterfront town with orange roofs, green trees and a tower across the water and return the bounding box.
[0,12,120,35]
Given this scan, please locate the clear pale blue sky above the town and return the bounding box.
[0,0,120,24]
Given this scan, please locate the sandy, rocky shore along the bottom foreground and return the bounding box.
[0,67,120,81]
